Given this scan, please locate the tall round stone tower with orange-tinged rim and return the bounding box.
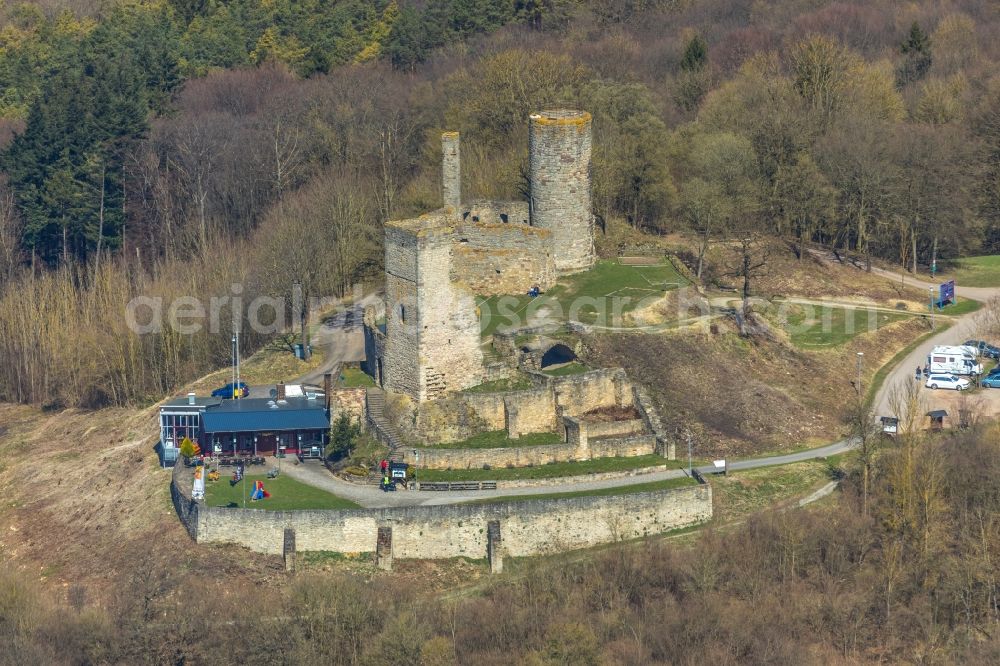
[528,109,594,274]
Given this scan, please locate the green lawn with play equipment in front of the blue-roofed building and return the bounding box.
[205,474,361,511]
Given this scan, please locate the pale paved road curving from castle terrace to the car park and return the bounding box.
[282,268,1000,508]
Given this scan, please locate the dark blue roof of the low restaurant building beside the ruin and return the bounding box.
[201,397,330,433]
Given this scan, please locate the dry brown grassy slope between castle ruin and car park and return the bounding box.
[584,312,926,457]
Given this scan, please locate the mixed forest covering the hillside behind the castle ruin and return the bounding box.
[0,0,1000,407]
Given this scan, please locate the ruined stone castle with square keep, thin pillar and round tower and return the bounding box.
[365,110,594,402]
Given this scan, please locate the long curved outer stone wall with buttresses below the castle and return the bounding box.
[184,485,712,559]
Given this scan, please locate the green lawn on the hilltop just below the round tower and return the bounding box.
[478,259,688,336]
